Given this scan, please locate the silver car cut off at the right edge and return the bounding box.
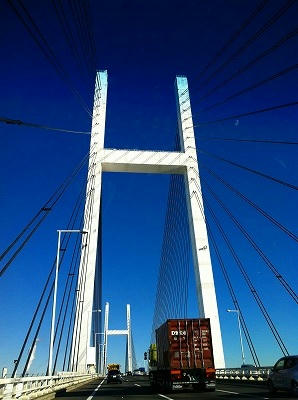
[268,355,298,395]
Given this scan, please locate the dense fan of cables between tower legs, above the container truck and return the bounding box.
[151,133,191,343]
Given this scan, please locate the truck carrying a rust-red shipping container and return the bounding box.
[149,318,215,391]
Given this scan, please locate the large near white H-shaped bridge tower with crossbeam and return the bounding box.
[72,71,225,372]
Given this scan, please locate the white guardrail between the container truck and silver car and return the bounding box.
[216,367,272,382]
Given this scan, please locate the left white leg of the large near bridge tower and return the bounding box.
[71,71,108,373]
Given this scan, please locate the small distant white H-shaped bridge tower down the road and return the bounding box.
[99,303,133,375]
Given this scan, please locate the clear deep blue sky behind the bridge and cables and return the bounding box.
[0,0,298,372]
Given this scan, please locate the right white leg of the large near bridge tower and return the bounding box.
[176,76,225,368]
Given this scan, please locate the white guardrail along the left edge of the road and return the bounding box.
[0,372,98,400]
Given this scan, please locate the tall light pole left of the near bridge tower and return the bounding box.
[48,229,88,376]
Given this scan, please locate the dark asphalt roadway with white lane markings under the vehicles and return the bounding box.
[56,376,294,400]
